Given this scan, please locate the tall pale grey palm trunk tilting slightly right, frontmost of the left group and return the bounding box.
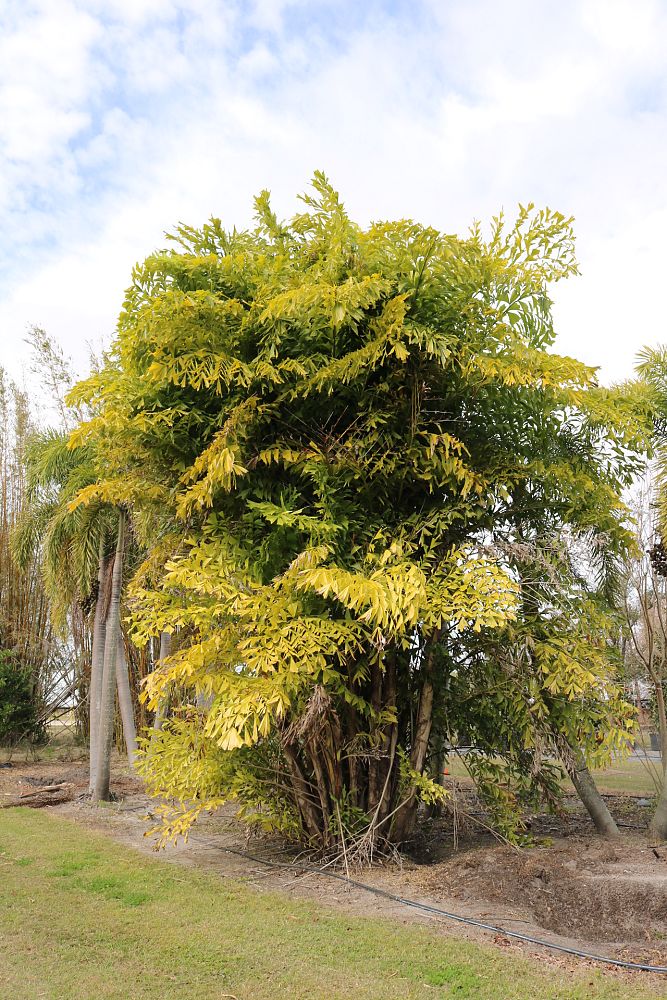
[93,511,125,801]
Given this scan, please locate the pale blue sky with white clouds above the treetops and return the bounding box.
[0,0,667,383]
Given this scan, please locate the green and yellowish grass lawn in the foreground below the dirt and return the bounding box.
[0,809,667,1000]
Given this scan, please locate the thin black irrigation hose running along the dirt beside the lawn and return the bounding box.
[223,847,667,974]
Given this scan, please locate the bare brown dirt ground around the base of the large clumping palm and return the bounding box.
[0,758,667,980]
